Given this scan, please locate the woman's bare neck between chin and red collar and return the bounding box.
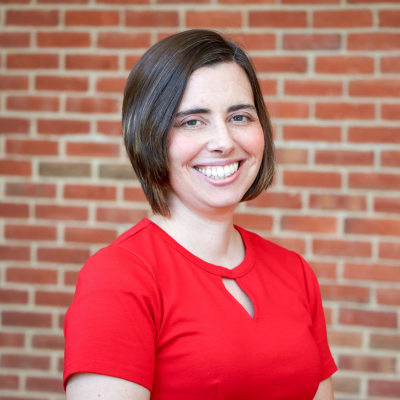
[150,203,245,269]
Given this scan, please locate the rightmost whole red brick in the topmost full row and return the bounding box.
[313,10,372,28]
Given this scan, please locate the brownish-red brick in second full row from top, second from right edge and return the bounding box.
[283,34,340,50]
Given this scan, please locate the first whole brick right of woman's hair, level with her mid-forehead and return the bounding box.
[285,80,342,96]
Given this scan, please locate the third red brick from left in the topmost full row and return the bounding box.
[125,11,177,27]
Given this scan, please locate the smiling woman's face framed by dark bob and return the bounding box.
[169,63,264,217]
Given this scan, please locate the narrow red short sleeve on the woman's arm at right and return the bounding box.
[299,256,337,381]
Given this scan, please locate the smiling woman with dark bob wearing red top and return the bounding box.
[64,30,336,400]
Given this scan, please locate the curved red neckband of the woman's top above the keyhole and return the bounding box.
[143,218,255,279]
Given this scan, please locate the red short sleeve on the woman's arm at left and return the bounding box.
[63,246,161,390]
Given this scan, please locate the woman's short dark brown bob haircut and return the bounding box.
[122,29,274,217]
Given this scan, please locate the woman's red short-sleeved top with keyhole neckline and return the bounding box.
[64,219,337,400]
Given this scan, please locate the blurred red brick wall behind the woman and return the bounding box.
[0,0,400,400]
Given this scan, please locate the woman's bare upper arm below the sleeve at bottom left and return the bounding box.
[67,373,150,400]
